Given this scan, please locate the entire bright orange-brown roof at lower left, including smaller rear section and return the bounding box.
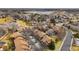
[12,32,31,51]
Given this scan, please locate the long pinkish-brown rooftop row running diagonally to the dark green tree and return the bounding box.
[34,29,52,45]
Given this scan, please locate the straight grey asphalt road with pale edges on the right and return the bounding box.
[60,30,72,51]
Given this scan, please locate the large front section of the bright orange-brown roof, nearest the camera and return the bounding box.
[14,37,31,51]
